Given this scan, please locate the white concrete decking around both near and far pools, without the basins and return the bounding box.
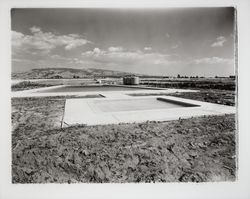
[12,85,236,127]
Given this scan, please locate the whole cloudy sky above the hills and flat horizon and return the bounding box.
[11,7,235,76]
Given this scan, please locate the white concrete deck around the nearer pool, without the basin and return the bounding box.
[63,95,236,127]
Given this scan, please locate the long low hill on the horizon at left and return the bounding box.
[11,68,139,79]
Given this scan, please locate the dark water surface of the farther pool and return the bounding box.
[39,86,157,93]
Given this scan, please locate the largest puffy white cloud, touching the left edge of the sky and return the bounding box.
[12,26,91,54]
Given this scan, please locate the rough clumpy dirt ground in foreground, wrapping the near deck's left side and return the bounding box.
[12,97,236,183]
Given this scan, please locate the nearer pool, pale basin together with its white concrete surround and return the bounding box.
[63,96,235,126]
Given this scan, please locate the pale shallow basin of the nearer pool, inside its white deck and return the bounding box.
[94,98,196,112]
